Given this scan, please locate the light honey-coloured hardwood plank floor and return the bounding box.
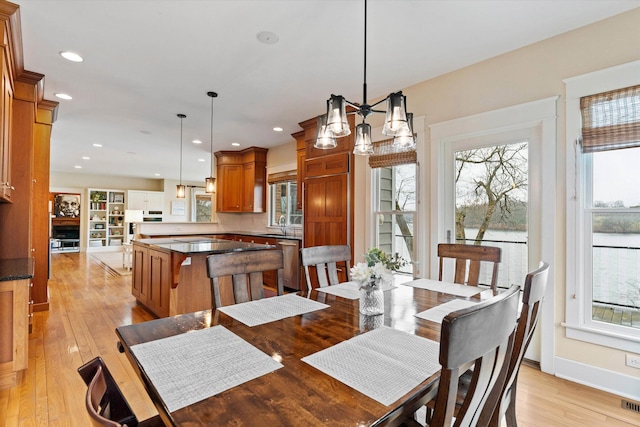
[0,253,640,427]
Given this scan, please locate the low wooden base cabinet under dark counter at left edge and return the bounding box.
[0,279,30,388]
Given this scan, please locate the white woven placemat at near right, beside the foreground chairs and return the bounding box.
[302,326,440,405]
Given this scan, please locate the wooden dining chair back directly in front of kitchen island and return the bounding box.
[207,250,284,308]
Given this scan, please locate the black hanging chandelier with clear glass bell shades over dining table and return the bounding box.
[314,0,416,155]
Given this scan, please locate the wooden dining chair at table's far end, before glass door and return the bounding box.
[438,243,502,290]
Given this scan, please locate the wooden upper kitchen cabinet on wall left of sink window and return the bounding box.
[215,147,268,212]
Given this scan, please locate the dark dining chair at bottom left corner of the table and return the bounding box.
[78,357,164,427]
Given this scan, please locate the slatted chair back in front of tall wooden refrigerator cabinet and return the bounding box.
[300,245,351,291]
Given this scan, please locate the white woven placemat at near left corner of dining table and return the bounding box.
[131,326,283,412]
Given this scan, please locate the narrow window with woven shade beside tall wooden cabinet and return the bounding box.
[369,140,418,275]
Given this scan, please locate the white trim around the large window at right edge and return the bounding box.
[561,61,640,352]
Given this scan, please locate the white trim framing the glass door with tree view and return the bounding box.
[429,96,559,374]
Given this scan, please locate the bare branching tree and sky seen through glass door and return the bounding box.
[455,142,528,245]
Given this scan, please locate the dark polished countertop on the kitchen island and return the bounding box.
[136,236,275,255]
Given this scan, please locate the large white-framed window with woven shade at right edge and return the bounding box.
[564,61,640,351]
